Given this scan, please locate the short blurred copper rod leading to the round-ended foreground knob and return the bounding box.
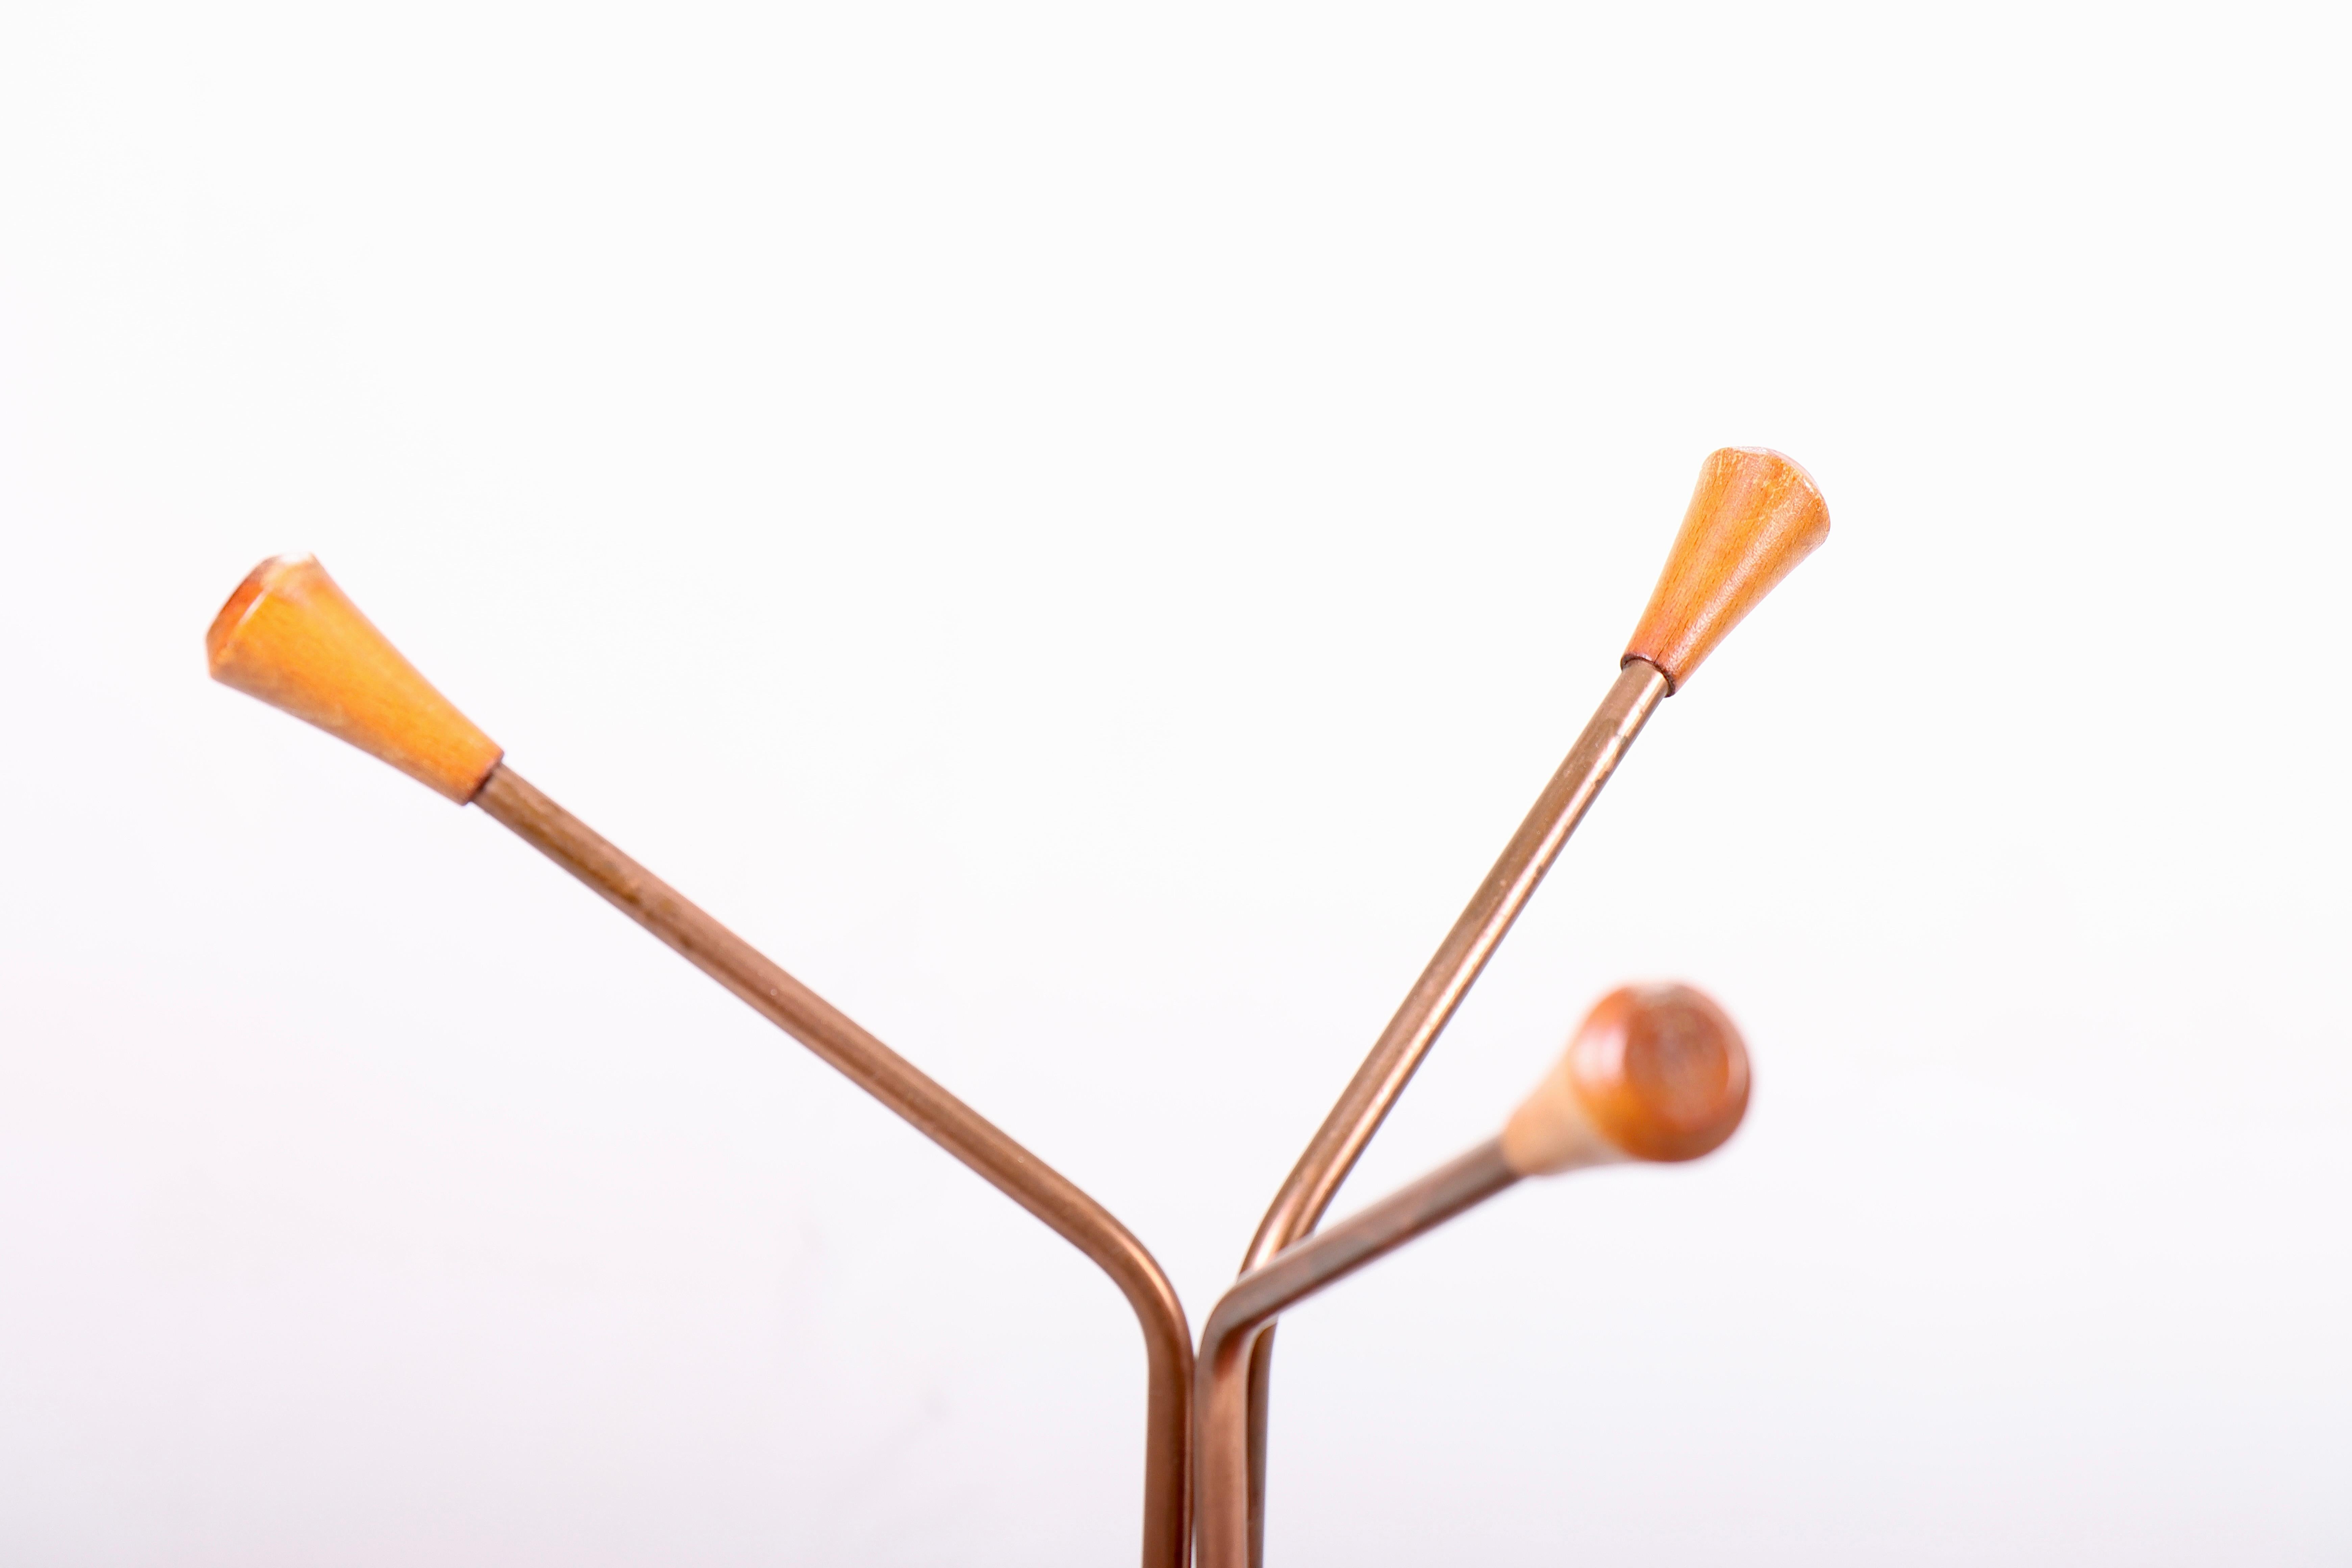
[1193,1138,1519,1568]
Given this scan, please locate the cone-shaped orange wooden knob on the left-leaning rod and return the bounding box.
[205,555,501,806]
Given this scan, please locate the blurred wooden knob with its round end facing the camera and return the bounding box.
[1503,985,1747,1175]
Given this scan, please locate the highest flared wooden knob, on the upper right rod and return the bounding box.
[1623,447,1830,691]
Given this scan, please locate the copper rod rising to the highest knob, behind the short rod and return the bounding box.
[1242,656,1672,1563]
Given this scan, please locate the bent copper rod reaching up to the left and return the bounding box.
[473,764,1193,1568]
